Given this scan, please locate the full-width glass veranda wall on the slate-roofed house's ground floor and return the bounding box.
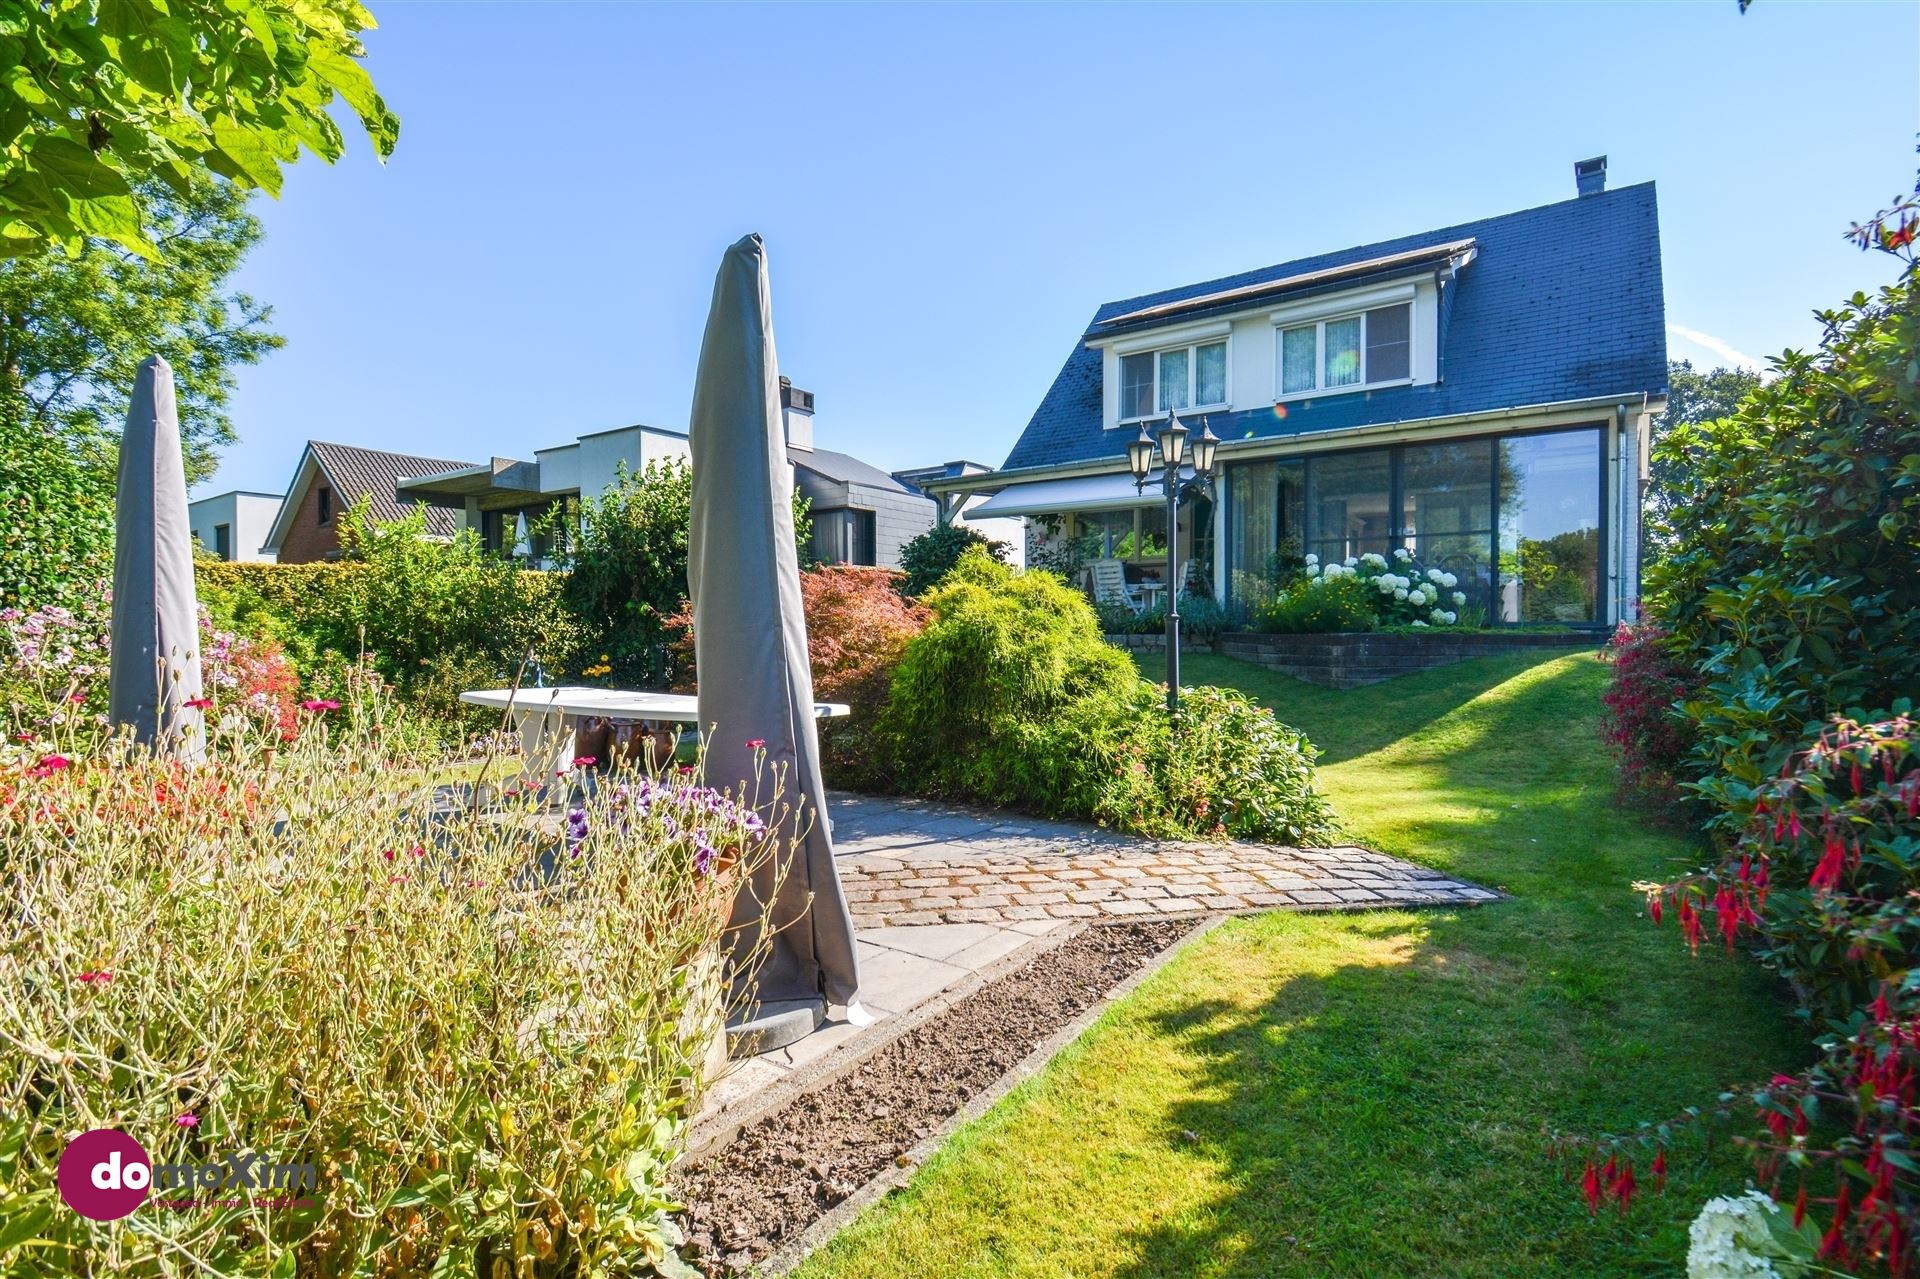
[1223,426,1605,626]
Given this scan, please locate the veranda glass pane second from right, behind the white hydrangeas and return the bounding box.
[1400,440,1494,622]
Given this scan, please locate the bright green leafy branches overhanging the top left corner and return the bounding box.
[0,0,399,257]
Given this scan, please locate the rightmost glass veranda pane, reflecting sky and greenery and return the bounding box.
[1496,430,1603,624]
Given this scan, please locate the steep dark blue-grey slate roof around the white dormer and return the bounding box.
[1002,182,1667,471]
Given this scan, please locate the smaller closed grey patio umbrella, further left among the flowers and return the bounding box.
[108,355,207,760]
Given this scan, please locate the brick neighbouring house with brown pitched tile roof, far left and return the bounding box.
[263,440,470,565]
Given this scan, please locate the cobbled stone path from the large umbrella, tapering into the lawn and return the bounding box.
[829,793,1498,928]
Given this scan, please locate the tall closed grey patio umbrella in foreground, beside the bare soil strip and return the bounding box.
[687,236,860,1050]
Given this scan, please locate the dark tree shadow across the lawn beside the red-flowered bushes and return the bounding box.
[1116,663,1799,1279]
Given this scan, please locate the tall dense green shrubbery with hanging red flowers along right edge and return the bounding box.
[1574,184,1920,1275]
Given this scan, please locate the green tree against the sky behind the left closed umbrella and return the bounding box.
[0,179,282,484]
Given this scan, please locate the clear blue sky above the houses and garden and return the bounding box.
[198,0,1920,494]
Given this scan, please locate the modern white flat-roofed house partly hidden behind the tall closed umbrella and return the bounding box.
[397,378,935,568]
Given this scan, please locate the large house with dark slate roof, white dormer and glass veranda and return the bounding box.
[925,157,1667,626]
